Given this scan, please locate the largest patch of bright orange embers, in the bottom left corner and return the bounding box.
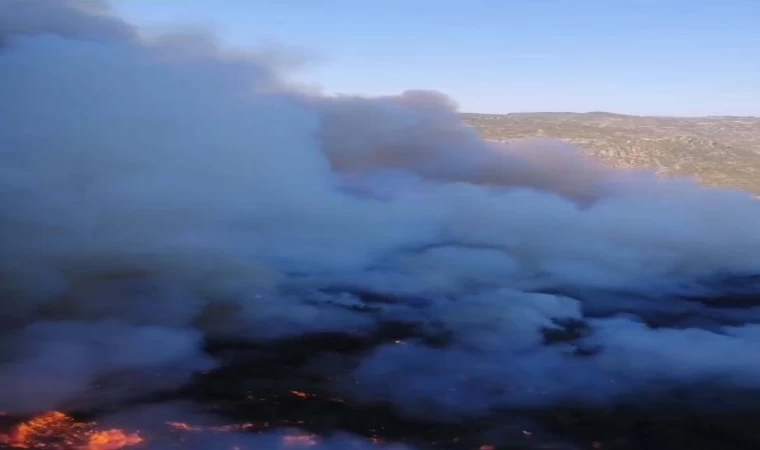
[0,411,143,450]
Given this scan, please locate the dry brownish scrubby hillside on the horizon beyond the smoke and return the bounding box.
[463,112,760,195]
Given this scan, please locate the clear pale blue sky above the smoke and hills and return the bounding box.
[116,0,760,115]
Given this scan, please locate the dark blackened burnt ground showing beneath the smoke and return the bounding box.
[0,286,760,450]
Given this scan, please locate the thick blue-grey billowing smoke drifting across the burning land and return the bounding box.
[0,0,760,434]
